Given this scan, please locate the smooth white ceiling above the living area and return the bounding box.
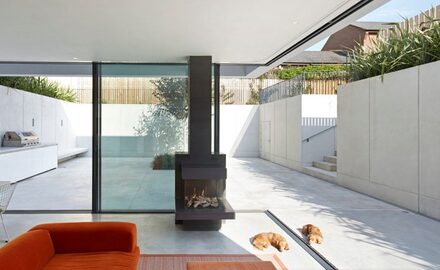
[0,0,385,64]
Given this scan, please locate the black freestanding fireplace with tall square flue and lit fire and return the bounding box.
[175,56,235,230]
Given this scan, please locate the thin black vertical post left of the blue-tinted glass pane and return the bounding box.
[92,62,101,213]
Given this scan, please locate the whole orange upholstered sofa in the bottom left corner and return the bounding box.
[0,222,139,270]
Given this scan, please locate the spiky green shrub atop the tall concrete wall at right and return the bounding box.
[348,15,440,81]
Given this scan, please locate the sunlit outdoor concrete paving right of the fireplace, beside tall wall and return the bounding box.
[228,159,440,269]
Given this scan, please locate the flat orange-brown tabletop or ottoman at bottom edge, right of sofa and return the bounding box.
[187,261,276,270]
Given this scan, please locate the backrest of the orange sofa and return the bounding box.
[31,222,137,254]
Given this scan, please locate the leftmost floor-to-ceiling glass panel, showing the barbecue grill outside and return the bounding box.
[0,63,92,211]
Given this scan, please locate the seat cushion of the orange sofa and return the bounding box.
[43,250,139,270]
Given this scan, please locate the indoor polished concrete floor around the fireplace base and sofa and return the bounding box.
[0,213,322,269]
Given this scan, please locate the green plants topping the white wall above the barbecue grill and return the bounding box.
[0,77,76,102]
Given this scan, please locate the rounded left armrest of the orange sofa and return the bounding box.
[0,230,54,270]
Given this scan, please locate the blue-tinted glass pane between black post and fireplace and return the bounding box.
[101,64,189,211]
